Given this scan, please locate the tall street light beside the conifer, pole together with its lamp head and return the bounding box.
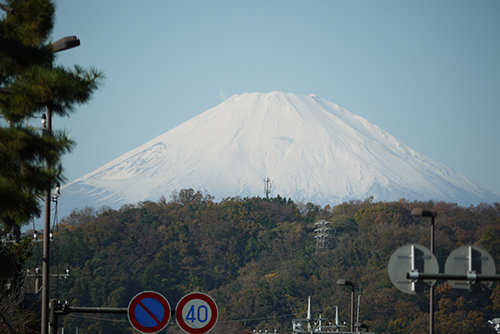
[41,36,80,334]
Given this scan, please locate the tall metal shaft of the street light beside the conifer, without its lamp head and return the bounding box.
[41,108,52,334]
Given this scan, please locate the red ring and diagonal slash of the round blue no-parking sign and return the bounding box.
[127,291,171,334]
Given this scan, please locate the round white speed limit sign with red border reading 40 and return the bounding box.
[175,292,219,334]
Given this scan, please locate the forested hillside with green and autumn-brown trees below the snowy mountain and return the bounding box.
[26,189,500,334]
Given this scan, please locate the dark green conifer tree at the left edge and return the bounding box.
[0,0,102,235]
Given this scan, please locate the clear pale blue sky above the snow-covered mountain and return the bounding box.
[52,0,500,196]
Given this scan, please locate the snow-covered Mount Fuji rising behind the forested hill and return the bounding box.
[59,92,500,214]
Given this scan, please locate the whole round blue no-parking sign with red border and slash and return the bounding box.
[127,291,171,334]
